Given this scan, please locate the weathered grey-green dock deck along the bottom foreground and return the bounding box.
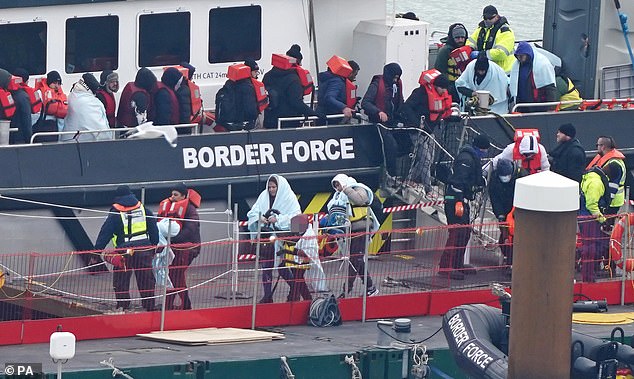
[0,306,634,373]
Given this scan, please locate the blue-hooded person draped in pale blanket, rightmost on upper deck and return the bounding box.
[509,41,557,112]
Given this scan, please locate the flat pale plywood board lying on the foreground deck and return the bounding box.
[137,328,285,346]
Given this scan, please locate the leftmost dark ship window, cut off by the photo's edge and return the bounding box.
[0,22,47,75]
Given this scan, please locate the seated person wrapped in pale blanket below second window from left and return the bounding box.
[61,73,113,142]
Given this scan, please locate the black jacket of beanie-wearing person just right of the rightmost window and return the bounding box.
[262,67,317,129]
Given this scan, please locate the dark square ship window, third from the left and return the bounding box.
[139,12,191,67]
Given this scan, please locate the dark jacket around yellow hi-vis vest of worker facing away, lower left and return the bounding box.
[95,194,158,250]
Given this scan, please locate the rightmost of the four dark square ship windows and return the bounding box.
[209,5,262,63]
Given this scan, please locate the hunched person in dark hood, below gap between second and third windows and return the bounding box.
[117,67,157,128]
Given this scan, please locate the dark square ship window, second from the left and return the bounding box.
[65,16,119,74]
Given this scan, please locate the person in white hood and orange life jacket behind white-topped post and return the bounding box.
[493,135,550,174]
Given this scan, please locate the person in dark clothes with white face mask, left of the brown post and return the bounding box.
[488,159,528,273]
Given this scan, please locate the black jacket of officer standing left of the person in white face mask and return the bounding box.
[445,145,484,201]
